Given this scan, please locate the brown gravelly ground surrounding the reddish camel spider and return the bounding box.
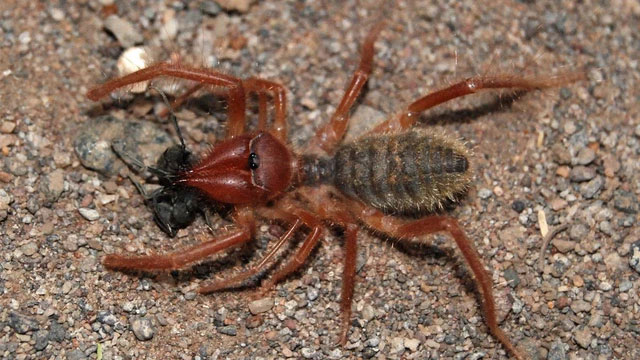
[0,0,640,360]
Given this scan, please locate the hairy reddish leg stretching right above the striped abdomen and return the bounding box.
[372,72,584,133]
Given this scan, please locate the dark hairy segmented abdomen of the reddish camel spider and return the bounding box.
[332,130,471,214]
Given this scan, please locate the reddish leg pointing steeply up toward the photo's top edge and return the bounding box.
[309,22,384,153]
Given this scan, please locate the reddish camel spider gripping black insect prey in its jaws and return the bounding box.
[87,23,582,358]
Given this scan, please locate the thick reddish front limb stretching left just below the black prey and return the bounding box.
[102,209,255,270]
